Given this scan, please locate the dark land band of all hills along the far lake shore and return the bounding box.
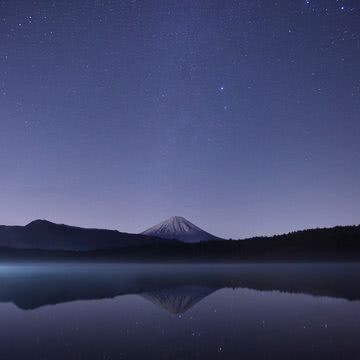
[0,220,360,261]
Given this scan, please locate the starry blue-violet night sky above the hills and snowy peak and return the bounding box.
[0,0,360,238]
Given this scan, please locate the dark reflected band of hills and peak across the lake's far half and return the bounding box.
[0,264,360,313]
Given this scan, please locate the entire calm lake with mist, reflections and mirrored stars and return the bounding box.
[0,264,360,360]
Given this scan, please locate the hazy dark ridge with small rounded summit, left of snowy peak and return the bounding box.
[0,220,172,251]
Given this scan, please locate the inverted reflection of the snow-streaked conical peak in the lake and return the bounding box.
[141,286,215,314]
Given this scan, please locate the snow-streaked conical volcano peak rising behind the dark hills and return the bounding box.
[141,216,220,243]
